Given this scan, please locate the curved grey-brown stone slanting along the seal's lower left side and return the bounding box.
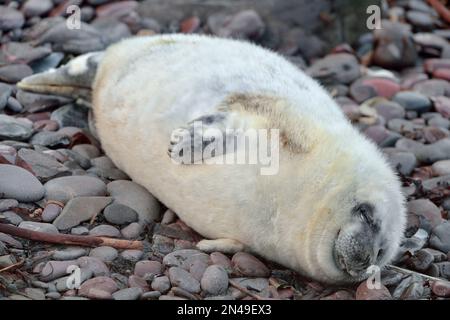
[107,180,160,222]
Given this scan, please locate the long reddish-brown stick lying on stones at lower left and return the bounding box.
[0,223,143,249]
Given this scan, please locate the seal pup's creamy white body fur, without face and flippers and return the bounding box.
[93,35,405,282]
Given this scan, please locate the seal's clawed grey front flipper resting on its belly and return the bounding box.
[168,112,246,164]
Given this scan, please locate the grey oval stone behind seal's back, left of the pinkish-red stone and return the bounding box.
[307,53,361,84]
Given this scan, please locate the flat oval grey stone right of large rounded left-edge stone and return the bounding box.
[44,176,106,203]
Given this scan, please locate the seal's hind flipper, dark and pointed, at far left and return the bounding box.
[17,51,103,101]
